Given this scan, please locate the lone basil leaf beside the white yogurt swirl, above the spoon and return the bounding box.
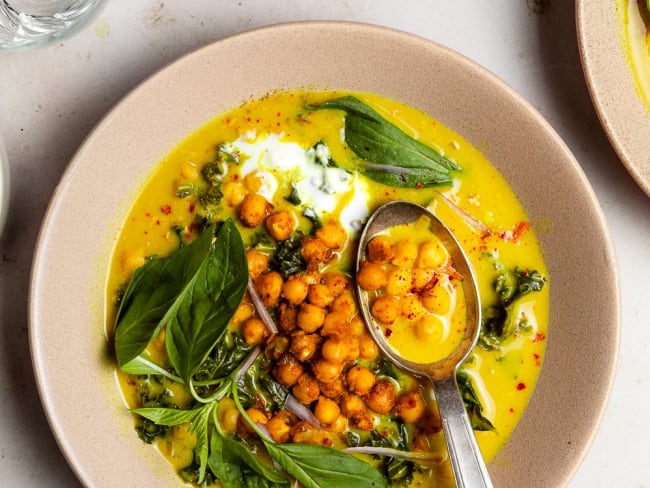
[310,96,461,188]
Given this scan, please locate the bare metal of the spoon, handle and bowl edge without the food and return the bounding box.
[357,201,492,488]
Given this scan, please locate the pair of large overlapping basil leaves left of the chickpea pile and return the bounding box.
[115,220,248,386]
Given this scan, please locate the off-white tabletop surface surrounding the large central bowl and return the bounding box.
[0,0,650,488]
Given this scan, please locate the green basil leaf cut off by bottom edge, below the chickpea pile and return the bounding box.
[264,442,388,488]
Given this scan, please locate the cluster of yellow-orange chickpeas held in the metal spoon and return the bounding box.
[357,235,459,344]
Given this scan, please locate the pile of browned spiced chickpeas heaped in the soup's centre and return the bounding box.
[222,194,439,449]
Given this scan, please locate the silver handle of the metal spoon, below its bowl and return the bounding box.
[432,375,492,488]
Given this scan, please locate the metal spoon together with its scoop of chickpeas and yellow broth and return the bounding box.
[356,201,492,488]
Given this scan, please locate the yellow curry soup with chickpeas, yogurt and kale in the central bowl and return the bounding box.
[106,90,549,486]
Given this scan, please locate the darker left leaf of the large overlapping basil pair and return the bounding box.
[115,228,213,367]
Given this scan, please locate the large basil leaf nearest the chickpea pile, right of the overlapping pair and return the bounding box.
[162,219,248,385]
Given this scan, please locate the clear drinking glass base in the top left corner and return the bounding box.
[0,0,105,50]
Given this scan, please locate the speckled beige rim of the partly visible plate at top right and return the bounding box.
[576,0,650,195]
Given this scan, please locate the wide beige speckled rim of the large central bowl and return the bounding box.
[30,22,619,488]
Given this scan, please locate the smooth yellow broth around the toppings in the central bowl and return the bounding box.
[106,90,549,486]
